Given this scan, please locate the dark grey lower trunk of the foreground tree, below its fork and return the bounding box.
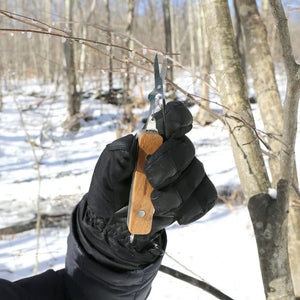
[248,184,294,300]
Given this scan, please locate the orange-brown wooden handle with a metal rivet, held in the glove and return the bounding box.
[128,133,163,234]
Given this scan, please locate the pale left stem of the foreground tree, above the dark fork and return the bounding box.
[203,0,270,199]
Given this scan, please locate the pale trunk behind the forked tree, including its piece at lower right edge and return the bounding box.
[236,0,300,294]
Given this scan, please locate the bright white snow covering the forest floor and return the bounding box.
[0,73,300,300]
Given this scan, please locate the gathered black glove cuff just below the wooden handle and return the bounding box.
[76,197,167,270]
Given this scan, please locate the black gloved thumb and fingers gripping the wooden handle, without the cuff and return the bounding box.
[87,101,217,236]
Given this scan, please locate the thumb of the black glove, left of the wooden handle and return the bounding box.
[87,134,137,218]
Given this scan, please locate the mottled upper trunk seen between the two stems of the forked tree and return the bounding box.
[236,0,283,188]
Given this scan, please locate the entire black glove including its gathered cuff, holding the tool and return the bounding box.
[77,102,217,268]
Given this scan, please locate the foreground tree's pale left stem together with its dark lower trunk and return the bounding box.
[203,0,293,299]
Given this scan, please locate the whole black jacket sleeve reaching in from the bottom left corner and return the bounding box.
[0,198,166,300]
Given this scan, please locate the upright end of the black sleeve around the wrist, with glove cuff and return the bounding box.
[66,198,166,300]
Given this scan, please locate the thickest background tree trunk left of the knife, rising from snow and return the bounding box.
[64,0,81,131]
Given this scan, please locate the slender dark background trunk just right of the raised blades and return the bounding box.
[163,0,174,97]
